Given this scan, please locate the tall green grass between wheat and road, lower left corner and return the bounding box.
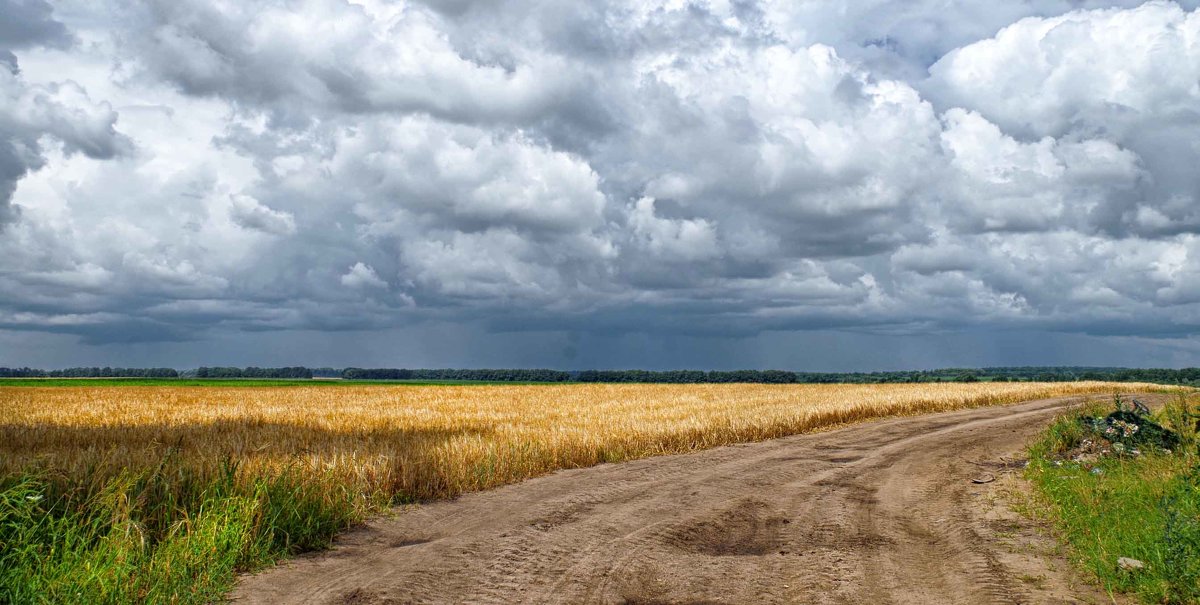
[0,456,391,604]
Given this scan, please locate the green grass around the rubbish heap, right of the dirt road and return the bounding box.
[1027,402,1200,604]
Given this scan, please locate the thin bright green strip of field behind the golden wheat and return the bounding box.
[0,378,571,388]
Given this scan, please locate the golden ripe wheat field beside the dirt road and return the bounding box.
[0,382,1160,498]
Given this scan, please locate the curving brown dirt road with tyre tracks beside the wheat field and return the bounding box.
[233,399,1132,605]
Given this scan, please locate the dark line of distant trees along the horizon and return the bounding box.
[7,366,1200,385]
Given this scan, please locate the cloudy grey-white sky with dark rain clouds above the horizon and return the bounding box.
[0,0,1200,371]
